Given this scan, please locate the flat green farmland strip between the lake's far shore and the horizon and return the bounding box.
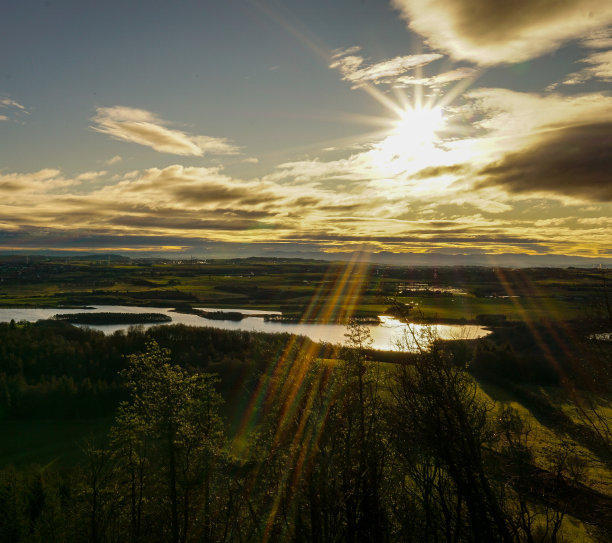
[0,257,605,322]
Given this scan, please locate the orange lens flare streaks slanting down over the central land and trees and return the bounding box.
[231,256,369,541]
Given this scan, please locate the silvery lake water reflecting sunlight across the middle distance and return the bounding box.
[0,305,490,351]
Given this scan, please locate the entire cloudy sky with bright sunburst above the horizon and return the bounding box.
[0,0,612,264]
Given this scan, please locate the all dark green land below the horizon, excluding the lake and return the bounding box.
[0,259,612,543]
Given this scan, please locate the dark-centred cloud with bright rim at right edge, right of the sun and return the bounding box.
[446,89,612,206]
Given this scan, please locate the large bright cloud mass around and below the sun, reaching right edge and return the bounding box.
[265,89,612,252]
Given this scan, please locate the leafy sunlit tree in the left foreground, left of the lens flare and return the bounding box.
[112,341,224,543]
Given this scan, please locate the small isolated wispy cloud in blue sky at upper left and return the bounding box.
[91,106,238,156]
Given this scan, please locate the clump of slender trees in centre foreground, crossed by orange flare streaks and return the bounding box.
[237,324,389,543]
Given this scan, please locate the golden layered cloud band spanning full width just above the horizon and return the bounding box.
[0,142,612,258]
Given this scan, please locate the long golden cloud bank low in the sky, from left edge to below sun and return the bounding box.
[0,164,378,246]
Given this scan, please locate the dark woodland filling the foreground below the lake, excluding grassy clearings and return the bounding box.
[0,306,612,542]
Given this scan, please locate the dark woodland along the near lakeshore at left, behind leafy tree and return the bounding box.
[0,320,334,418]
